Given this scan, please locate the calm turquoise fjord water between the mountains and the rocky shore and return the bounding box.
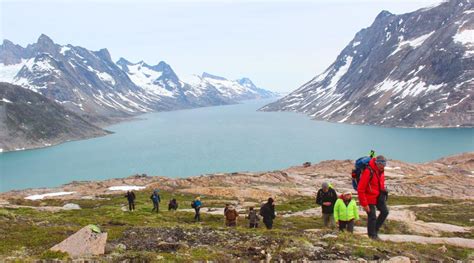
[0,100,474,191]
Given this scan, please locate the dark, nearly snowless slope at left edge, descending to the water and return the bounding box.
[0,82,109,152]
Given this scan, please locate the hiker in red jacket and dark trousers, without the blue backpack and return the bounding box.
[357,155,388,240]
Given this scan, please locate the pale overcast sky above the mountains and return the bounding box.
[0,0,441,93]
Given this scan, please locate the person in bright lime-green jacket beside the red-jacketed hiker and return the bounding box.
[334,192,359,233]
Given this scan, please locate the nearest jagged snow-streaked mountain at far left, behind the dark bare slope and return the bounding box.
[0,35,156,123]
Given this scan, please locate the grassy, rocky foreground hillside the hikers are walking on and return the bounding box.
[0,153,474,263]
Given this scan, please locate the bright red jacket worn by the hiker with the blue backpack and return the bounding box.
[357,158,385,206]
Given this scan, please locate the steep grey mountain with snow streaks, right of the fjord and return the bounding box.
[261,0,474,127]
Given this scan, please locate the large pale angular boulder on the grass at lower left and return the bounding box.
[51,226,107,258]
